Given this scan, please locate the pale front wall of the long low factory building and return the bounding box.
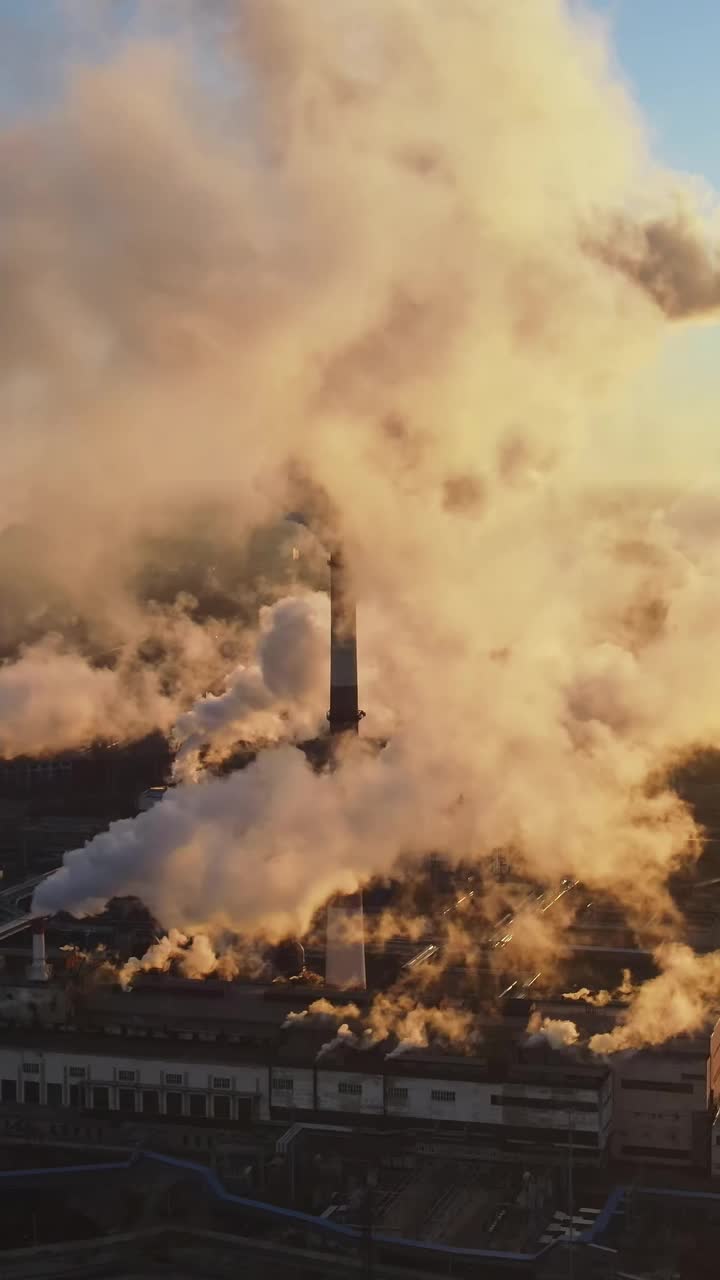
[0,1043,607,1149]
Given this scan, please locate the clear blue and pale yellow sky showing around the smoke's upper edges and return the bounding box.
[0,0,720,483]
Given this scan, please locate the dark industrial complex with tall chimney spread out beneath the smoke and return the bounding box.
[0,550,720,1276]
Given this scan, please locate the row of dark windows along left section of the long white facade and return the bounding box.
[0,1079,240,1120]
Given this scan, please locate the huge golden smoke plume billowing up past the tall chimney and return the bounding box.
[15,0,720,993]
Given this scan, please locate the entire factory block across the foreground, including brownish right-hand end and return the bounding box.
[0,978,720,1170]
